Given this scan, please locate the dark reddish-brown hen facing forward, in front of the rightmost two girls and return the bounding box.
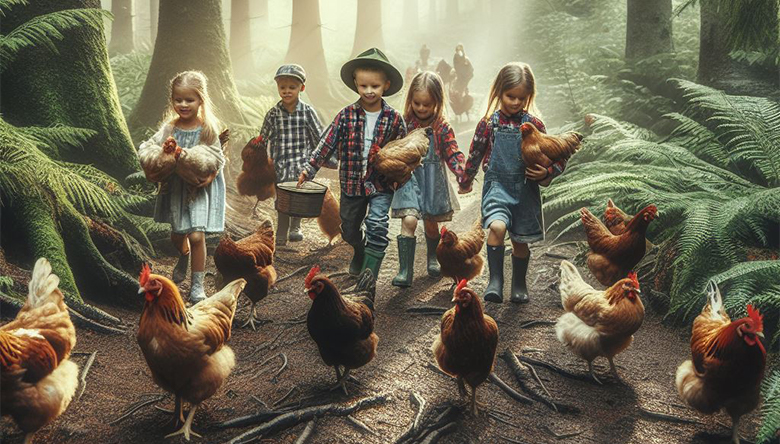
[431,279,498,415]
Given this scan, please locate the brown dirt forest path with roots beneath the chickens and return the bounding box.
[2,122,758,444]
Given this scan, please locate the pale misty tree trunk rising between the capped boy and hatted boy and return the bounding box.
[284,0,334,113]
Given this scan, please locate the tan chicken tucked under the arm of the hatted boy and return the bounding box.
[369,128,431,189]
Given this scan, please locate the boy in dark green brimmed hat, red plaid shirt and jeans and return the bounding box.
[298,48,406,278]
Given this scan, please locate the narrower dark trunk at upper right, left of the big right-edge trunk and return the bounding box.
[626,0,673,60]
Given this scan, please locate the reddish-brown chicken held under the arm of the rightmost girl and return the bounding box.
[520,122,582,172]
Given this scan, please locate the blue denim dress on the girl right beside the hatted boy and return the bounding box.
[392,134,453,220]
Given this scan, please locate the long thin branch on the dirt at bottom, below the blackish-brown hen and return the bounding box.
[228,395,390,444]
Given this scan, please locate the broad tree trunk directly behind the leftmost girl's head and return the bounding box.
[128,0,243,141]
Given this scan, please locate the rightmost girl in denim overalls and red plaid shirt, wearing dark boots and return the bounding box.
[459,63,565,303]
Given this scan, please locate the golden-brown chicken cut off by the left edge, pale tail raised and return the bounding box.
[0,258,79,444]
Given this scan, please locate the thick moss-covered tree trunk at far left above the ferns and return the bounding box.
[0,0,139,180]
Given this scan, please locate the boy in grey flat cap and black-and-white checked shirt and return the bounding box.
[260,64,322,245]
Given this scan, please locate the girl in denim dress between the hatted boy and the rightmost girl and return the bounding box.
[392,71,465,287]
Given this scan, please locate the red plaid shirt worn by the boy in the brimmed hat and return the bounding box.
[306,100,406,196]
